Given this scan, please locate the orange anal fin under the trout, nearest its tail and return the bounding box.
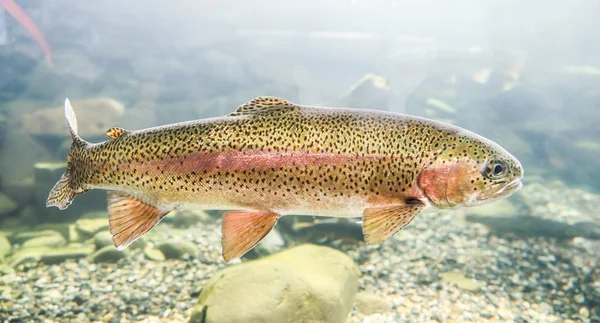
[108,192,169,250]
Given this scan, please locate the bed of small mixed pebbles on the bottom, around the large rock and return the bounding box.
[0,183,600,322]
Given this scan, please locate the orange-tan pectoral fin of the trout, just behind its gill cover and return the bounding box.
[363,202,425,245]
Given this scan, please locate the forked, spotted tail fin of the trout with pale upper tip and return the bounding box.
[46,99,84,210]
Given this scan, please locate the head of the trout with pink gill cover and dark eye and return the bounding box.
[417,134,523,208]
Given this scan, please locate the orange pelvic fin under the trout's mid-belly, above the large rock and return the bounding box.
[221,211,280,263]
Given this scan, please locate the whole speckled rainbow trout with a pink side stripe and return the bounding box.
[46,97,523,262]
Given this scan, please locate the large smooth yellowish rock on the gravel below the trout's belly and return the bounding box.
[190,244,359,323]
